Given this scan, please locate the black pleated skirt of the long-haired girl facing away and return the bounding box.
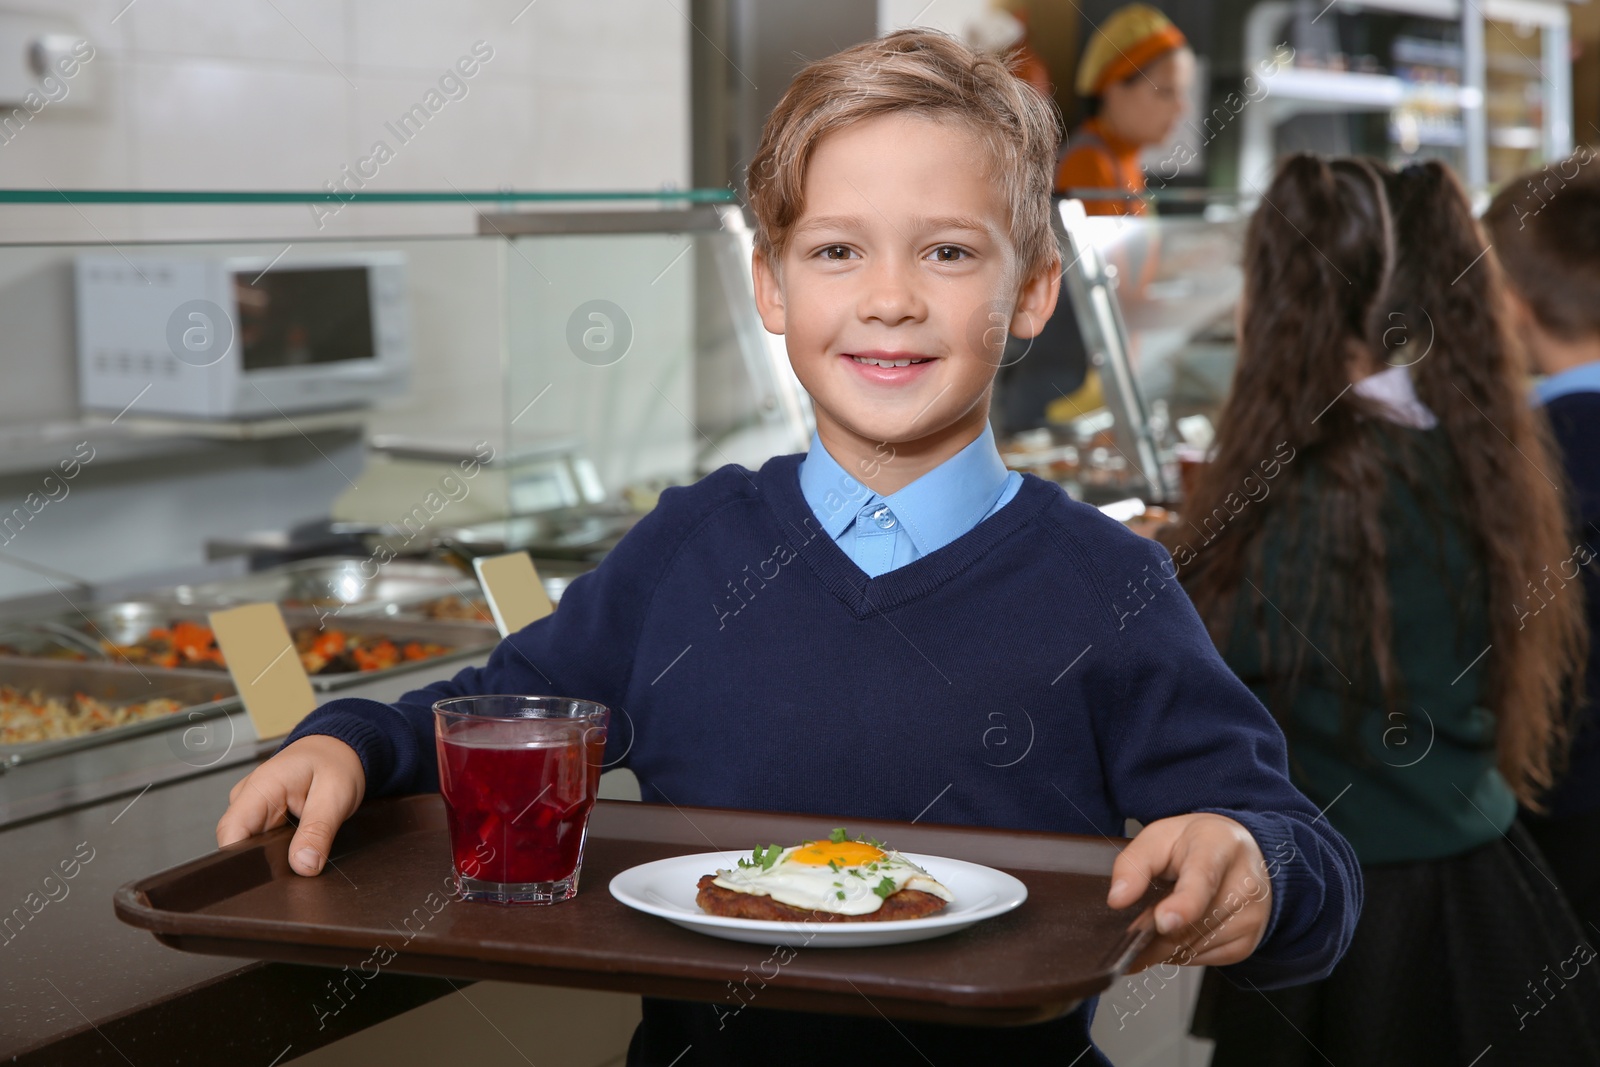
[1190,822,1600,1067]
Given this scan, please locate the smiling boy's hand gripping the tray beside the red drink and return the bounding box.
[216,734,366,875]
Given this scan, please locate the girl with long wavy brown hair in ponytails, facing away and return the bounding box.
[1162,155,1600,1067]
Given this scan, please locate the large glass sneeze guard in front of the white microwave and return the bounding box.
[0,189,811,777]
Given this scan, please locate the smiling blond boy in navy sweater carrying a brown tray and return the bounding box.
[218,30,1362,1067]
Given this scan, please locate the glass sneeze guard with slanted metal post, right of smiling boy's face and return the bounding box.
[1000,189,1251,514]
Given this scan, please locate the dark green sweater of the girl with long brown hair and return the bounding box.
[1224,424,1517,864]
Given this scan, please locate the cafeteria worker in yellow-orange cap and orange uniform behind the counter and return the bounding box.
[1056,3,1194,214]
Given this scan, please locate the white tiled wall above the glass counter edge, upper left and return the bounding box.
[0,0,693,240]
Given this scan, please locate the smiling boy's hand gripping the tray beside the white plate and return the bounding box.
[1106,814,1272,973]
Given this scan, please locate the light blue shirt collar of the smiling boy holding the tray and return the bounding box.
[800,424,1010,555]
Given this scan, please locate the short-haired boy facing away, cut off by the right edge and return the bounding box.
[1483,147,1600,926]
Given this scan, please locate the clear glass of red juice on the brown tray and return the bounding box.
[434,696,611,904]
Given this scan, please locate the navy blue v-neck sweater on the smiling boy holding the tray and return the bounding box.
[286,456,1362,1062]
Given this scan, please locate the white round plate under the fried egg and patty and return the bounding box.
[611,849,1027,949]
